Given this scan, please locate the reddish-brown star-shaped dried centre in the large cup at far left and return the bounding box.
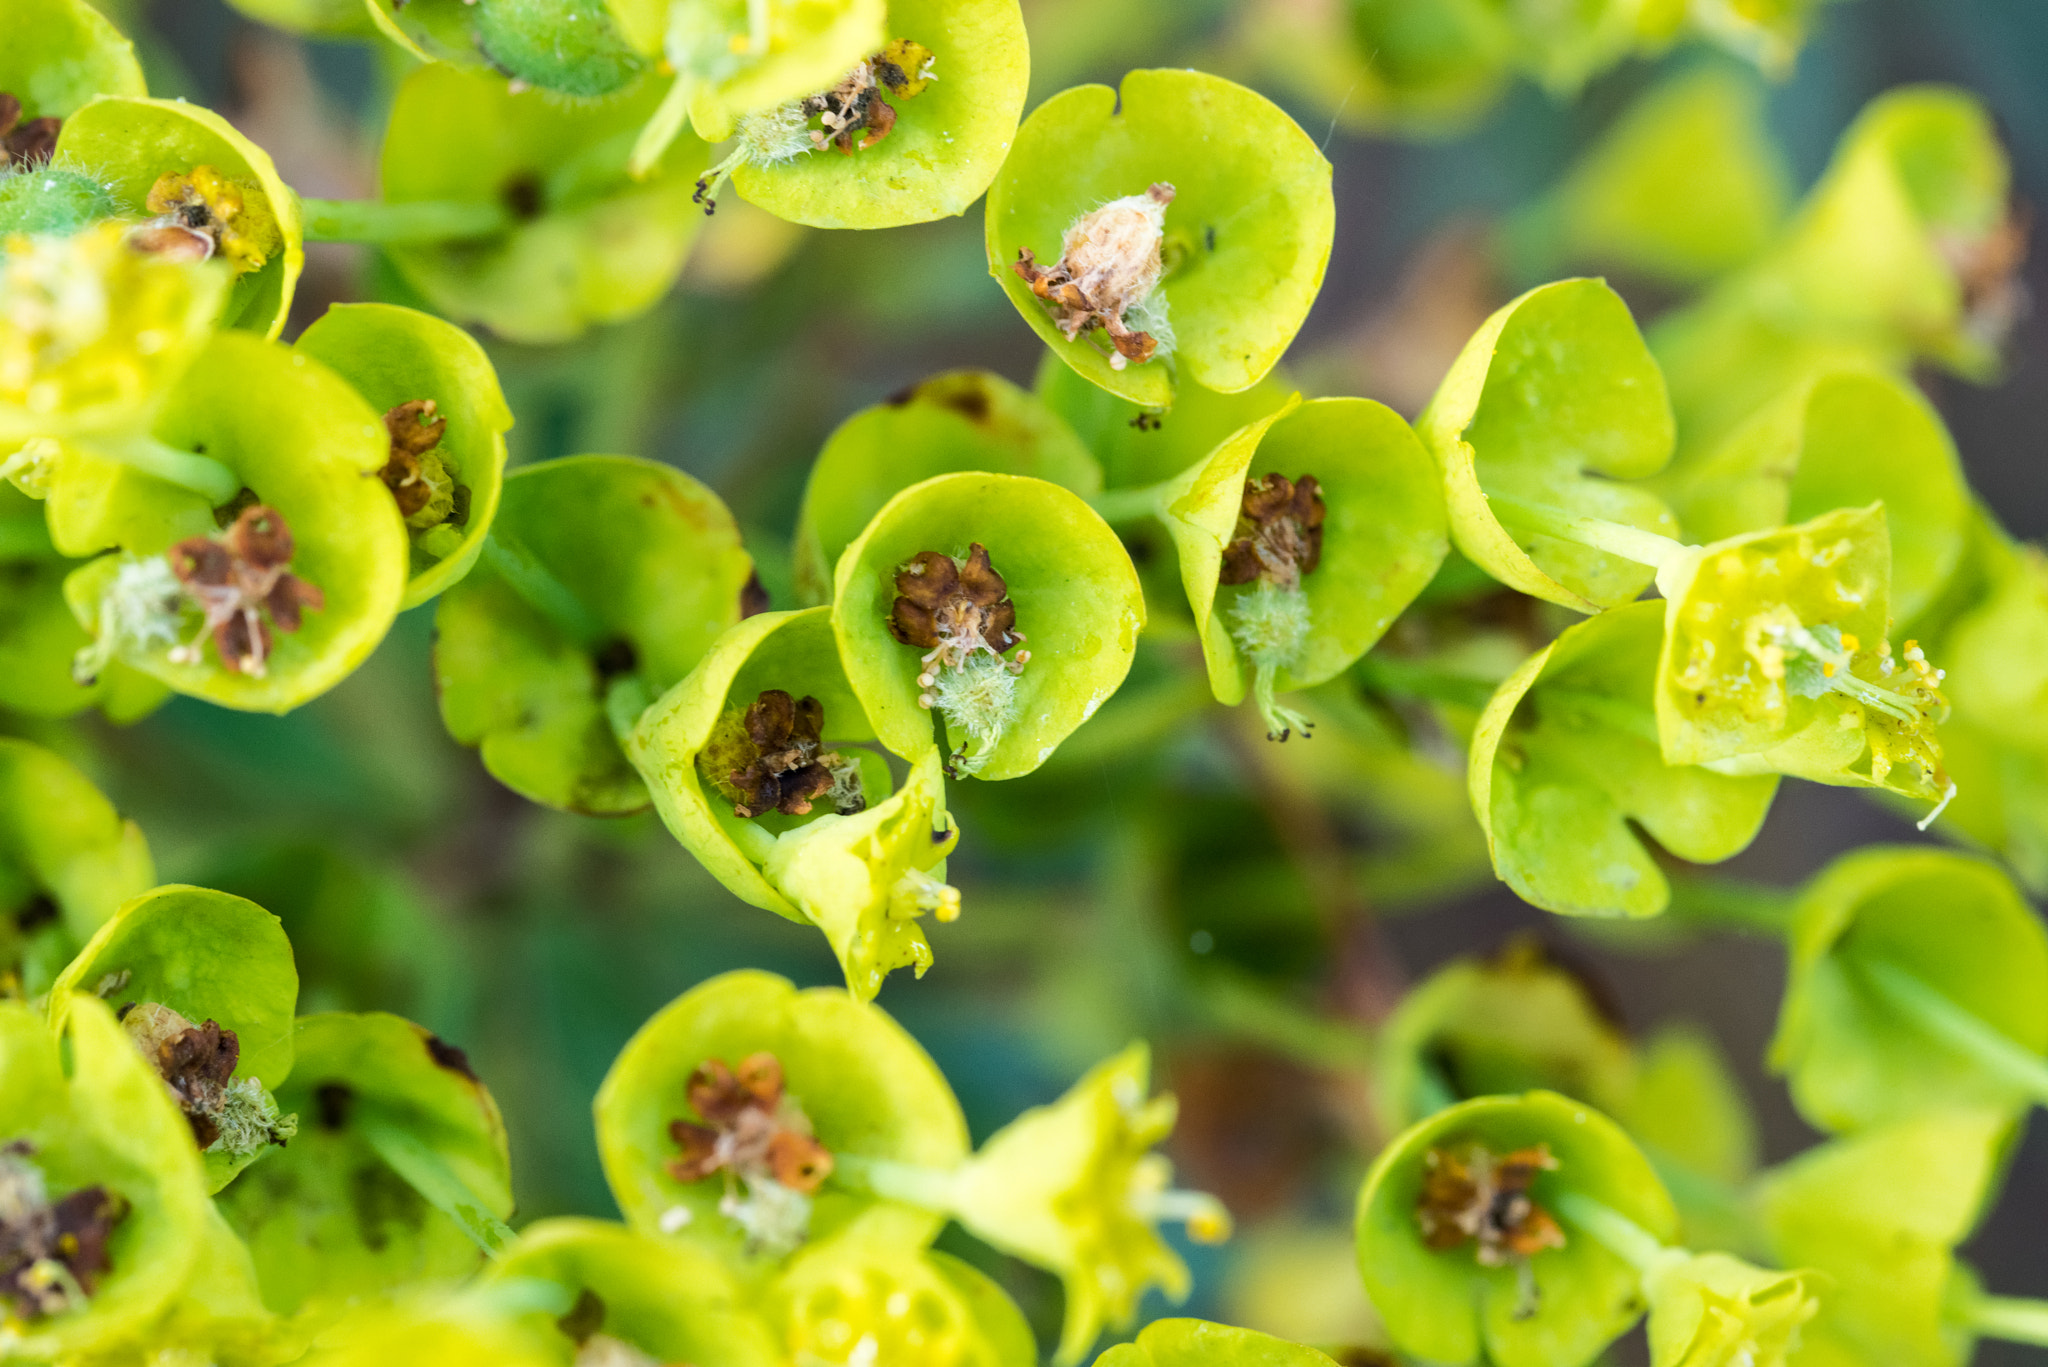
[166,504,328,678]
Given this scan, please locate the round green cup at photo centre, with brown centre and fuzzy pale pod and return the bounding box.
[831,473,1145,779]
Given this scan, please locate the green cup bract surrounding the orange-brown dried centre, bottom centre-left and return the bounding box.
[596,969,967,1269]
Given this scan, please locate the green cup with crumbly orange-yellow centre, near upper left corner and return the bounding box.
[57,98,305,338]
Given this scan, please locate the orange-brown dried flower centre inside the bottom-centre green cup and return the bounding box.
[668,1053,831,1193]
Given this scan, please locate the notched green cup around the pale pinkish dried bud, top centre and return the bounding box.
[987,70,1335,408]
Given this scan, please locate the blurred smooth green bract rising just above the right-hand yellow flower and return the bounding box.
[1659,369,1972,623]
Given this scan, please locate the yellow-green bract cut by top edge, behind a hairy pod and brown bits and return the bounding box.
[733,0,1030,227]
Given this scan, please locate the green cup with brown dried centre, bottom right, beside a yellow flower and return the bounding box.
[1358,1092,1677,1367]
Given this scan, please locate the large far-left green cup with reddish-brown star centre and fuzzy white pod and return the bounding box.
[59,332,406,711]
